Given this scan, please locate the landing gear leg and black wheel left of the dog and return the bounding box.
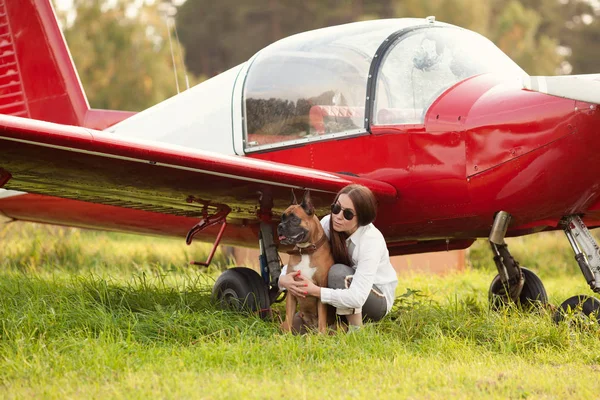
[212,222,281,318]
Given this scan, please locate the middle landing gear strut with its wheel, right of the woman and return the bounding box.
[489,211,548,309]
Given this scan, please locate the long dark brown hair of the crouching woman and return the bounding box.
[329,184,377,266]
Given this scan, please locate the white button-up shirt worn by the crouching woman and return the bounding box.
[321,215,398,312]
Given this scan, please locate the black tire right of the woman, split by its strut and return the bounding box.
[488,267,548,311]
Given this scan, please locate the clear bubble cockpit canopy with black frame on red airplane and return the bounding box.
[243,18,525,151]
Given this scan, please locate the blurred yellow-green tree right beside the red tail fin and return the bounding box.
[63,0,193,111]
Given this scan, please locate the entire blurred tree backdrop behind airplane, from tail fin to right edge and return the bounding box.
[56,0,600,111]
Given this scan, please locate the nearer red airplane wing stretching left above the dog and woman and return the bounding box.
[0,115,397,228]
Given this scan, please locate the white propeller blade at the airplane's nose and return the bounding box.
[522,74,600,104]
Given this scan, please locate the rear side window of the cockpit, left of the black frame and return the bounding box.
[246,54,368,145]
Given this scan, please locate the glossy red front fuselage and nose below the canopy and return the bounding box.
[252,76,600,243]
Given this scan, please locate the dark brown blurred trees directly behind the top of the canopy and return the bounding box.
[177,0,393,77]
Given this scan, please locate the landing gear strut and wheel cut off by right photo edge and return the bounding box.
[554,215,600,322]
